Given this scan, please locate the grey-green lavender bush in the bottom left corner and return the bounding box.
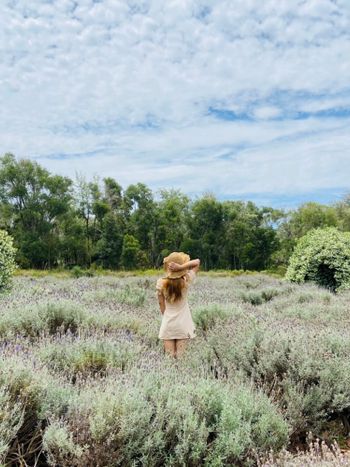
[0,358,74,466]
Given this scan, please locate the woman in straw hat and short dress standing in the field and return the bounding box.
[156,252,200,358]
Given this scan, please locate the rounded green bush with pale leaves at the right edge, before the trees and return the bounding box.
[285,227,350,291]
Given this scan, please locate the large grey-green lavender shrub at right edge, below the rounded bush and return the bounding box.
[215,328,350,441]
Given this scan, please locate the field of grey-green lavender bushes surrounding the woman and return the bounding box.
[0,274,350,467]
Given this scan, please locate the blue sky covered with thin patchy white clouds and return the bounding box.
[0,0,350,207]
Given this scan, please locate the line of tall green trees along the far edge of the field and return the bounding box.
[0,153,350,270]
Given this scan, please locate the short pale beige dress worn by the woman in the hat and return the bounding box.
[156,270,196,339]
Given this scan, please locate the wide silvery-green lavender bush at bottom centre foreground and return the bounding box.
[44,372,288,467]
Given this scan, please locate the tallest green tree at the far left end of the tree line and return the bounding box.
[0,154,72,268]
